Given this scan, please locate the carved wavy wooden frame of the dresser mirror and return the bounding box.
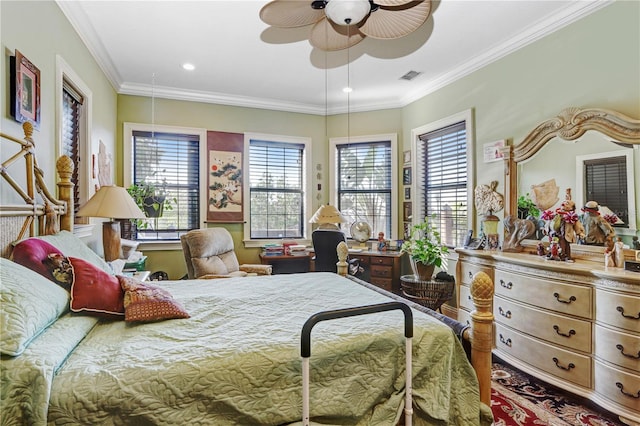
[502,107,640,217]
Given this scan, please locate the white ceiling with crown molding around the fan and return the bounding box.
[56,0,611,115]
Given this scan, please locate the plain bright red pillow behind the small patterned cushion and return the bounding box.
[69,257,124,319]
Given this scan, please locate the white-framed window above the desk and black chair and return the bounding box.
[330,135,398,239]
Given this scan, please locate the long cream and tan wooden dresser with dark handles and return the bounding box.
[456,249,640,424]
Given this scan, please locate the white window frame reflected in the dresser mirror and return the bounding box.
[575,149,638,235]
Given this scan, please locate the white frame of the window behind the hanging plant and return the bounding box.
[122,122,207,251]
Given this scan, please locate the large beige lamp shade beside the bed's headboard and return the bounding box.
[76,186,146,219]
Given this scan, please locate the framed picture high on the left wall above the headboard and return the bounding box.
[10,50,40,129]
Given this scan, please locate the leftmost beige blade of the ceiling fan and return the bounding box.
[260,0,324,28]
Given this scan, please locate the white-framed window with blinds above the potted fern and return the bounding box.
[412,112,473,247]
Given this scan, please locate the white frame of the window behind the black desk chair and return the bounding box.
[329,133,401,240]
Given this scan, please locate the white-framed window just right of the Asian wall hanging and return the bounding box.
[245,134,309,246]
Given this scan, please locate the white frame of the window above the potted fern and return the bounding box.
[411,109,476,245]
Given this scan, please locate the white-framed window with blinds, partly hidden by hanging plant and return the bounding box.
[124,123,206,242]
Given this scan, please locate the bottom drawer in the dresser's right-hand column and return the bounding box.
[595,361,640,412]
